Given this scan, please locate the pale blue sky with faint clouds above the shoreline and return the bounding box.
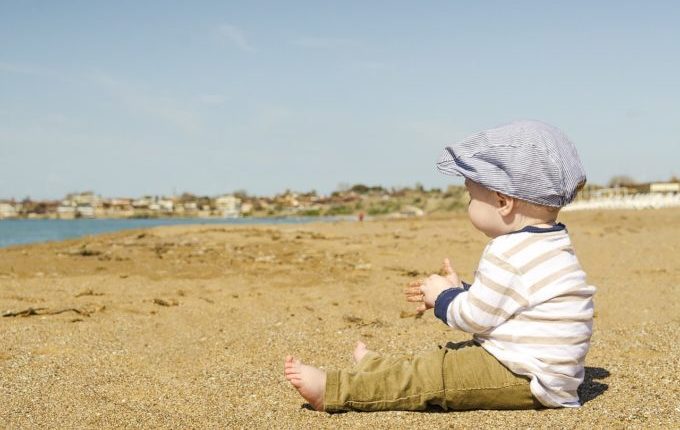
[0,0,680,198]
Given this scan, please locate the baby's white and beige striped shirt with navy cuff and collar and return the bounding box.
[435,224,595,407]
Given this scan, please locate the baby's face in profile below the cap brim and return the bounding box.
[465,179,507,237]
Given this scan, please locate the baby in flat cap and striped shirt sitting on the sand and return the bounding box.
[284,121,595,412]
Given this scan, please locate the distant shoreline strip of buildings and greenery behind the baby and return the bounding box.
[0,179,680,219]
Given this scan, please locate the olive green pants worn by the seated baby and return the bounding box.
[324,341,543,412]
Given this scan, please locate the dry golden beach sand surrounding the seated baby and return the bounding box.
[0,210,680,429]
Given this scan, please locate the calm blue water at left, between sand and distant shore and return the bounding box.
[0,217,338,248]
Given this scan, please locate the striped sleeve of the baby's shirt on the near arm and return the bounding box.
[440,252,529,333]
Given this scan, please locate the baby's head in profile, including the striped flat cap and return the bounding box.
[437,121,586,237]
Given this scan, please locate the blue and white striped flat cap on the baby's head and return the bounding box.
[437,120,586,207]
